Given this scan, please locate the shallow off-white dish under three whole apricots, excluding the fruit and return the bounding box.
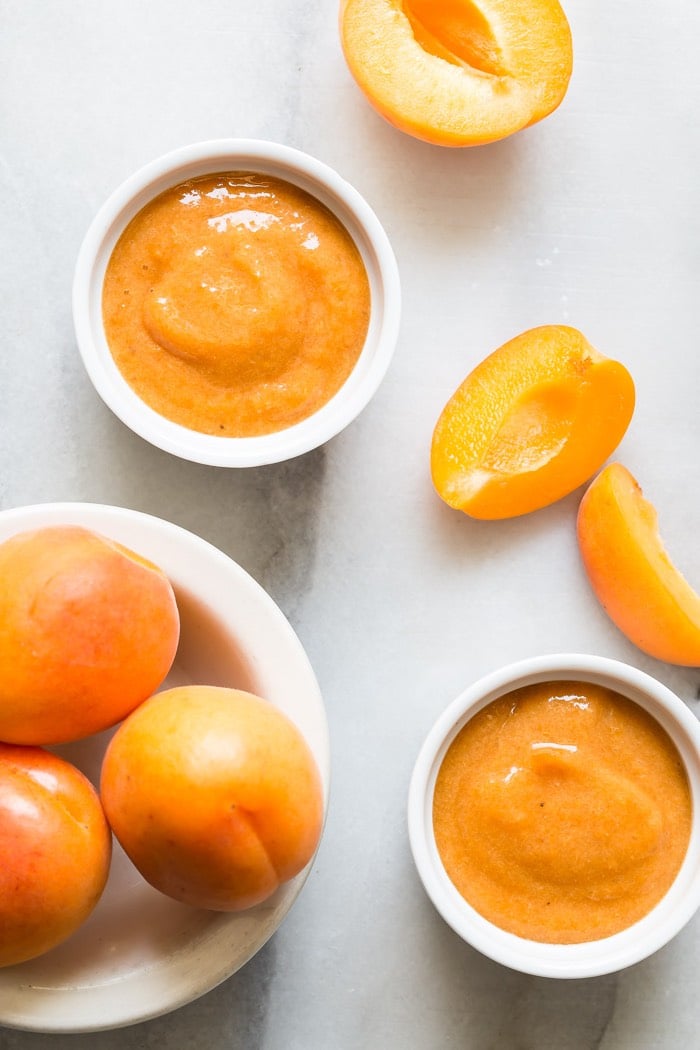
[0,503,330,1032]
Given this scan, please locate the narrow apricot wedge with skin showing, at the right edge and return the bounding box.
[577,463,700,667]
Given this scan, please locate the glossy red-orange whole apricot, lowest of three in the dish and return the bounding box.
[0,743,111,966]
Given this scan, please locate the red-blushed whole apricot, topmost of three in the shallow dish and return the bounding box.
[0,526,179,744]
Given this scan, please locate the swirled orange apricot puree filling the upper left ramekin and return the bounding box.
[103,172,369,437]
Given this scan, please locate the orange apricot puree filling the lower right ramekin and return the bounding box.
[432,681,692,944]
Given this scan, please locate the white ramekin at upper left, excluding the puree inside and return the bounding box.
[72,139,401,467]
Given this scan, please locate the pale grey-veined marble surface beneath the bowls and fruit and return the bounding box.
[0,0,700,1050]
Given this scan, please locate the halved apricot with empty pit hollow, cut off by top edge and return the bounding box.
[340,0,573,146]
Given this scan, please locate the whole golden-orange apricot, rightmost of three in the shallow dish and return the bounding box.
[101,686,323,911]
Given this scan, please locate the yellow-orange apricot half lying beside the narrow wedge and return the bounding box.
[430,324,635,519]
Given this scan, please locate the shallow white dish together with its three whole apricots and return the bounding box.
[0,503,330,1032]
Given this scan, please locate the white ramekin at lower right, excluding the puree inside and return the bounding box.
[408,654,700,978]
